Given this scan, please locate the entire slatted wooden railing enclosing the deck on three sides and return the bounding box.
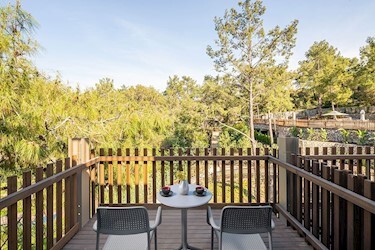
[0,146,375,249]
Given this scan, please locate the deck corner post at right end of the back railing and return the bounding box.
[277,137,299,223]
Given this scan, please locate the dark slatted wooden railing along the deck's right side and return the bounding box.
[270,155,375,249]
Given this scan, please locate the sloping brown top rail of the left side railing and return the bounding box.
[0,157,98,210]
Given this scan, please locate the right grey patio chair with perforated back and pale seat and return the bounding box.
[207,206,275,250]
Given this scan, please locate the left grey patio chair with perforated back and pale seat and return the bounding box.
[93,207,161,250]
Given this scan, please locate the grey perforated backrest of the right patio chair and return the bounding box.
[221,206,272,234]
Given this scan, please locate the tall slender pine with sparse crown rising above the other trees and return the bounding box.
[207,0,298,153]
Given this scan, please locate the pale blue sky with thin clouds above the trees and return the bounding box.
[11,0,375,91]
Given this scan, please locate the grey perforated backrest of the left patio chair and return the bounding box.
[97,207,150,235]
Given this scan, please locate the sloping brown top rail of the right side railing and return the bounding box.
[269,156,375,214]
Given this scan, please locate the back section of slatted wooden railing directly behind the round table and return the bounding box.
[90,149,276,209]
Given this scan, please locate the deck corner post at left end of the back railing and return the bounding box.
[68,138,90,227]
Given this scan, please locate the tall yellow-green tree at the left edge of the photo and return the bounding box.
[0,1,50,168]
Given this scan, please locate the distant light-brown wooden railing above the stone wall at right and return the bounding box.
[254,119,375,130]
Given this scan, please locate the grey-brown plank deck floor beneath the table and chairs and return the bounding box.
[64,209,312,250]
